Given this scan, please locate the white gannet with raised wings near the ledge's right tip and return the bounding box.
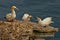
[37,17,53,26]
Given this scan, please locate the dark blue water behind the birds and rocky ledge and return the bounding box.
[0,0,60,40]
